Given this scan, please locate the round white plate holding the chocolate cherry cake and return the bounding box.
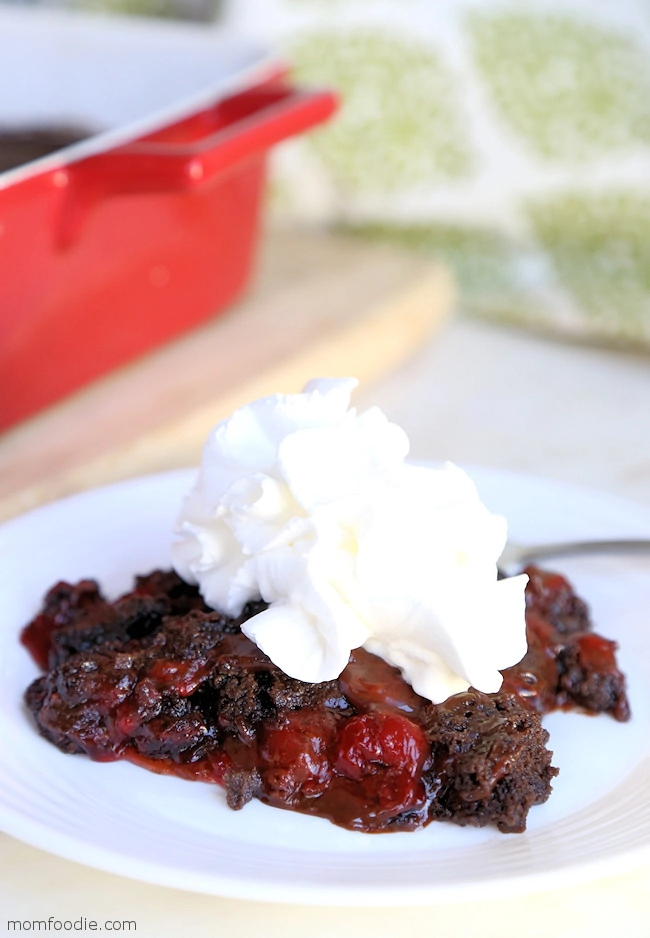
[0,470,650,905]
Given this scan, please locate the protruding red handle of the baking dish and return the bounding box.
[58,81,338,247]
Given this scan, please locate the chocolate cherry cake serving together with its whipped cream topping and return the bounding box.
[22,380,629,832]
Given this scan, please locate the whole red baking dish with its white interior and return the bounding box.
[0,7,336,429]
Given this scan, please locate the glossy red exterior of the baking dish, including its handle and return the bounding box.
[0,9,336,428]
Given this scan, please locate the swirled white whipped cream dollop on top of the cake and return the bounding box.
[172,379,527,703]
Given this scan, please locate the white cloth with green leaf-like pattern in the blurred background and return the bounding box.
[228,0,650,347]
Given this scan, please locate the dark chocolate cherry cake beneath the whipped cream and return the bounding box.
[22,567,629,833]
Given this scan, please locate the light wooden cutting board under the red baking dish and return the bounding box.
[0,231,453,519]
